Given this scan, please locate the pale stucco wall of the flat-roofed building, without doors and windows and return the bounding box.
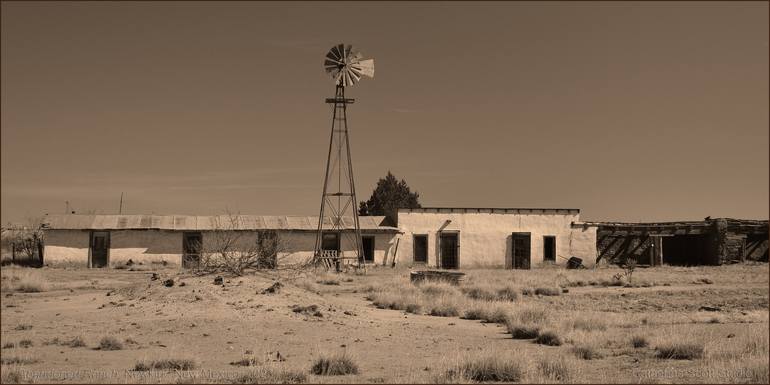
[398,212,596,268]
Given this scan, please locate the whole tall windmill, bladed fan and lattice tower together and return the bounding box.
[314,44,374,271]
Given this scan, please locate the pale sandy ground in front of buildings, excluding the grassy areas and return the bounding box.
[0,265,768,383]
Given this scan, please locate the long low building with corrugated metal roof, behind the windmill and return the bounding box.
[43,215,398,267]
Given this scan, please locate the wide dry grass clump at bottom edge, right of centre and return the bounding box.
[445,353,524,382]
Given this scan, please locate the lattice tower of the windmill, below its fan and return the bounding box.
[314,84,365,271]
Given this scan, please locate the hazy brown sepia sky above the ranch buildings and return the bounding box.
[1,1,770,223]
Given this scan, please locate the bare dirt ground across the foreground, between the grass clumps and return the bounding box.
[0,264,768,383]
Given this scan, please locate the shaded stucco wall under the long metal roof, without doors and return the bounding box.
[44,230,394,266]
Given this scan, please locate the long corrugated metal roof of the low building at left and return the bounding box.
[43,214,398,232]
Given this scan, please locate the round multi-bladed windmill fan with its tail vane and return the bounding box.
[324,44,374,87]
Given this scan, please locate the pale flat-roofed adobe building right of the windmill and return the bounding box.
[397,207,596,269]
